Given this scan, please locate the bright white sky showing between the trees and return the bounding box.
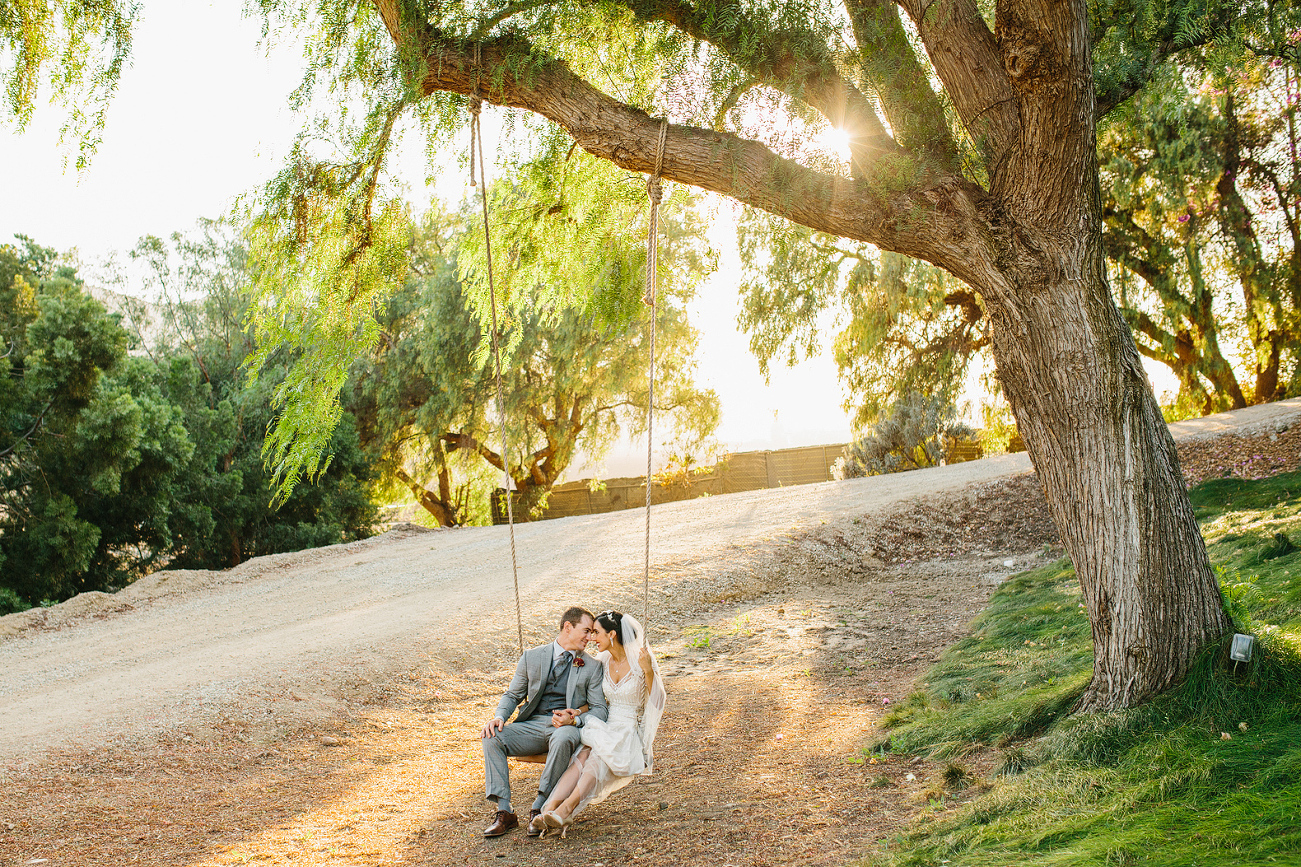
[0,0,850,478]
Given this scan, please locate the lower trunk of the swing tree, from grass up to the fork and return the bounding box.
[987,186,1232,711]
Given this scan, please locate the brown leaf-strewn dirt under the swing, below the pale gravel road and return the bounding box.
[0,486,1054,867]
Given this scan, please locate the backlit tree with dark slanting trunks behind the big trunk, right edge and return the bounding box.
[1101,52,1301,414]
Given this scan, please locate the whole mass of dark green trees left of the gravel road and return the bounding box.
[0,224,375,613]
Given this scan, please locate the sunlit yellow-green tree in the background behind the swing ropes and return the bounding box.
[351,201,718,526]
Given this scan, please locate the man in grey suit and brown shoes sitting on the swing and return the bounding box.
[483,607,606,837]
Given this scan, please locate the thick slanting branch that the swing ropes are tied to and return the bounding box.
[403,26,998,284]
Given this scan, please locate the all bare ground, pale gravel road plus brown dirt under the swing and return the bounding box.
[0,401,1301,867]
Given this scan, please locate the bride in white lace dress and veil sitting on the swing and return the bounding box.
[532,611,665,837]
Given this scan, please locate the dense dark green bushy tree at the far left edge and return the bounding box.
[0,238,194,603]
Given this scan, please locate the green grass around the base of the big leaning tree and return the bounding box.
[870,473,1301,867]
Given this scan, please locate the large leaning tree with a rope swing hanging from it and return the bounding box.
[12,0,1297,709]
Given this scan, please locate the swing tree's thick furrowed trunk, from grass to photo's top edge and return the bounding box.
[985,0,1231,711]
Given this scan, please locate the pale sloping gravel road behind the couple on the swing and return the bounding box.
[0,456,1028,767]
